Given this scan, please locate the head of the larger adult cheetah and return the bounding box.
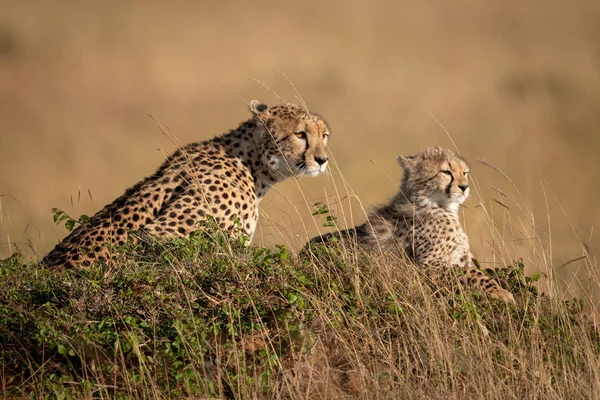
[250,100,329,177]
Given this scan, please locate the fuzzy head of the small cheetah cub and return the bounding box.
[398,147,470,210]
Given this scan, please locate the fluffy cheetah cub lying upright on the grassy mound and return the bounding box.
[311,147,515,303]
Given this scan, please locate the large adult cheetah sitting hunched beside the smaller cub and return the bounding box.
[42,100,329,267]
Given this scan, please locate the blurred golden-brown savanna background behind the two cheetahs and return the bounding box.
[0,0,600,294]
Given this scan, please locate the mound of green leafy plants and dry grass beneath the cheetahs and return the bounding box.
[0,234,600,399]
